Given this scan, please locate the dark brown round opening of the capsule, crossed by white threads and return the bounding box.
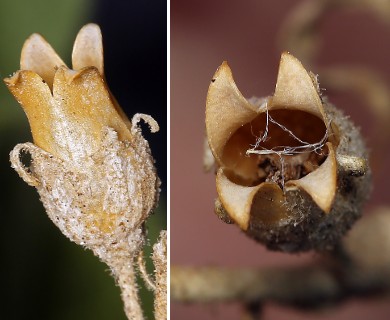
[222,109,328,188]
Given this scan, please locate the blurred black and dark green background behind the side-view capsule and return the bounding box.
[0,0,167,320]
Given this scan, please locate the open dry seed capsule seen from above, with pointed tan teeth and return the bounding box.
[206,53,370,252]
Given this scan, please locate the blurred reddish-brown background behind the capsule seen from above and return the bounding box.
[170,0,390,320]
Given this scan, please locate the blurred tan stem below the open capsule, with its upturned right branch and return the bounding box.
[171,208,390,308]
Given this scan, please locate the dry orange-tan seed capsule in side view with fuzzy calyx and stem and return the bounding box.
[5,24,160,319]
